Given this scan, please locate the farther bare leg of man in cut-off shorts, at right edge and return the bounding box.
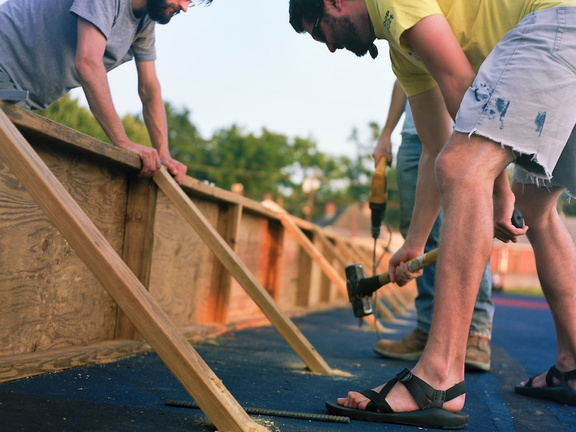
[513,183,576,390]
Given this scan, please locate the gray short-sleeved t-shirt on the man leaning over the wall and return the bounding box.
[0,0,156,109]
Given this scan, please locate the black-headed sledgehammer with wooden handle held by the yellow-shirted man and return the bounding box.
[344,209,524,318]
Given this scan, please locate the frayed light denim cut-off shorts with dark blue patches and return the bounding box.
[455,7,576,197]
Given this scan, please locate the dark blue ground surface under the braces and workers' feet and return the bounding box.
[0,294,576,432]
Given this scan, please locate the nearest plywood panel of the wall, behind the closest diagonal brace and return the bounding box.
[0,149,126,355]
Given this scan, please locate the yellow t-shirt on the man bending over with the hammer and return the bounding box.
[366,0,576,96]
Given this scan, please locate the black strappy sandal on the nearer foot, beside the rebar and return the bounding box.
[326,369,468,429]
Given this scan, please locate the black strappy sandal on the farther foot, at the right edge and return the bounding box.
[514,366,576,406]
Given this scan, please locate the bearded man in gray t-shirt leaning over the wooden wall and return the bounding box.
[0,0,211,183]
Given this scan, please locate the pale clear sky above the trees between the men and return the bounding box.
[0,0,400,157]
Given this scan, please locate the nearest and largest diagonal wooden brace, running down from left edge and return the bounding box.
[0,110,267,432]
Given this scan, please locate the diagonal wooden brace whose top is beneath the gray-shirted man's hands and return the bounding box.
[154,168,333,374]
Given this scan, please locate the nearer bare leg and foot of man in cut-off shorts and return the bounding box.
[338,133,514,412]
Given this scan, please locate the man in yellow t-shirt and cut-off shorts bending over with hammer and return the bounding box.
[290,0,576,428]
